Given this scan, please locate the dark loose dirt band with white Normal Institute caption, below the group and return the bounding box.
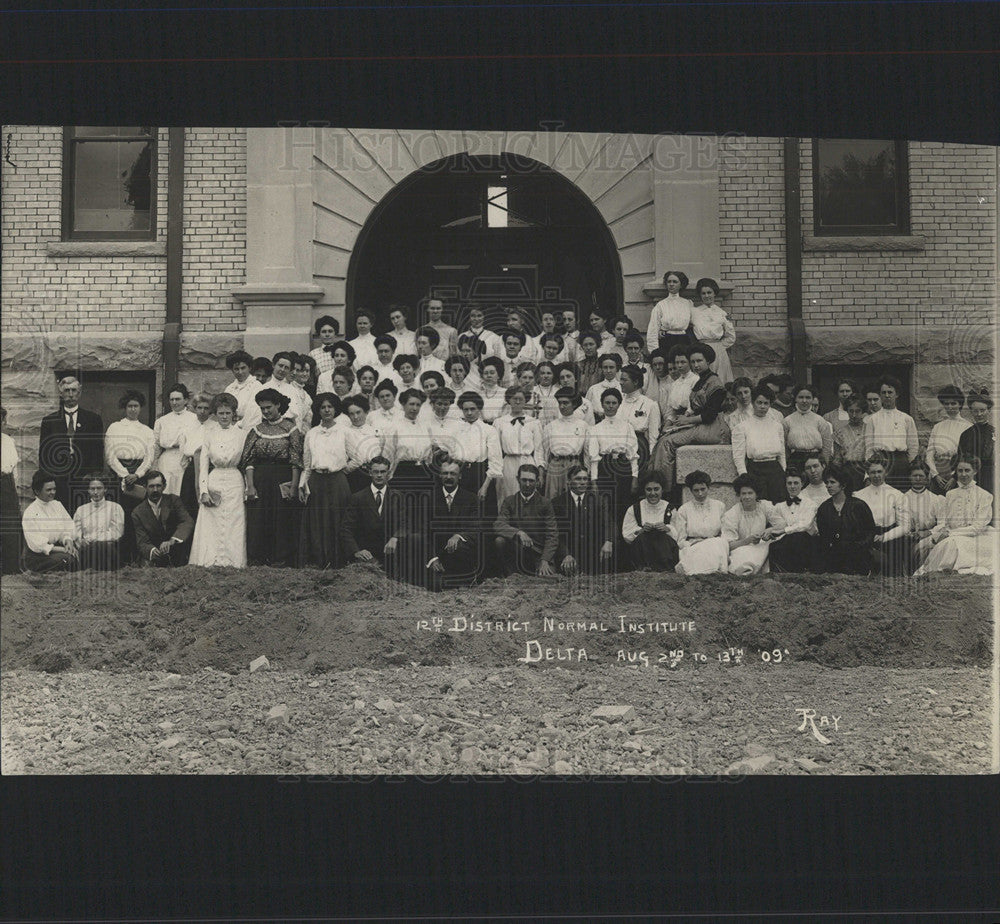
[0,565,992,673]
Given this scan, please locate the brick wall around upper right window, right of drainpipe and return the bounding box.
[800,139,997,327]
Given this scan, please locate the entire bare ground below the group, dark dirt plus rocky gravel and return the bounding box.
[0,566,995,778]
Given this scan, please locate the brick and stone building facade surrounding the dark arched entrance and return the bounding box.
[0,126,998,498]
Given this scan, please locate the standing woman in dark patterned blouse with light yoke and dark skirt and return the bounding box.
[239,388,302,567]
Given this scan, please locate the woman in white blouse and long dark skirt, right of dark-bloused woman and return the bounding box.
[299,392,351,568]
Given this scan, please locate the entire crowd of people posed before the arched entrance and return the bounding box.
[0,272,997,589]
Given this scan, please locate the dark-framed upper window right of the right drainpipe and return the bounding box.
[813,138,910,236]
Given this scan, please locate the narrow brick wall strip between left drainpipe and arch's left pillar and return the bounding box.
[183,128,247,333]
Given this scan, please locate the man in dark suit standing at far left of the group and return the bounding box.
[38,375,104,516]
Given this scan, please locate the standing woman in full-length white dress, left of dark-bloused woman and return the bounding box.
[189,392,247,568]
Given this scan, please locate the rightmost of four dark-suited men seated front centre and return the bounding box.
[552,465,614,575]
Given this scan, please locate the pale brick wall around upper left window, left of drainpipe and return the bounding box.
[0,126,167,332]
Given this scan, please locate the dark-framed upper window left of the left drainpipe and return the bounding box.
[62,125,156,241]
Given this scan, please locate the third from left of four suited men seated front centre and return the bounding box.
[493,464,559,576]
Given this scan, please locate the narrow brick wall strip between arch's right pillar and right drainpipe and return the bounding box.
[720,136,787,328]
